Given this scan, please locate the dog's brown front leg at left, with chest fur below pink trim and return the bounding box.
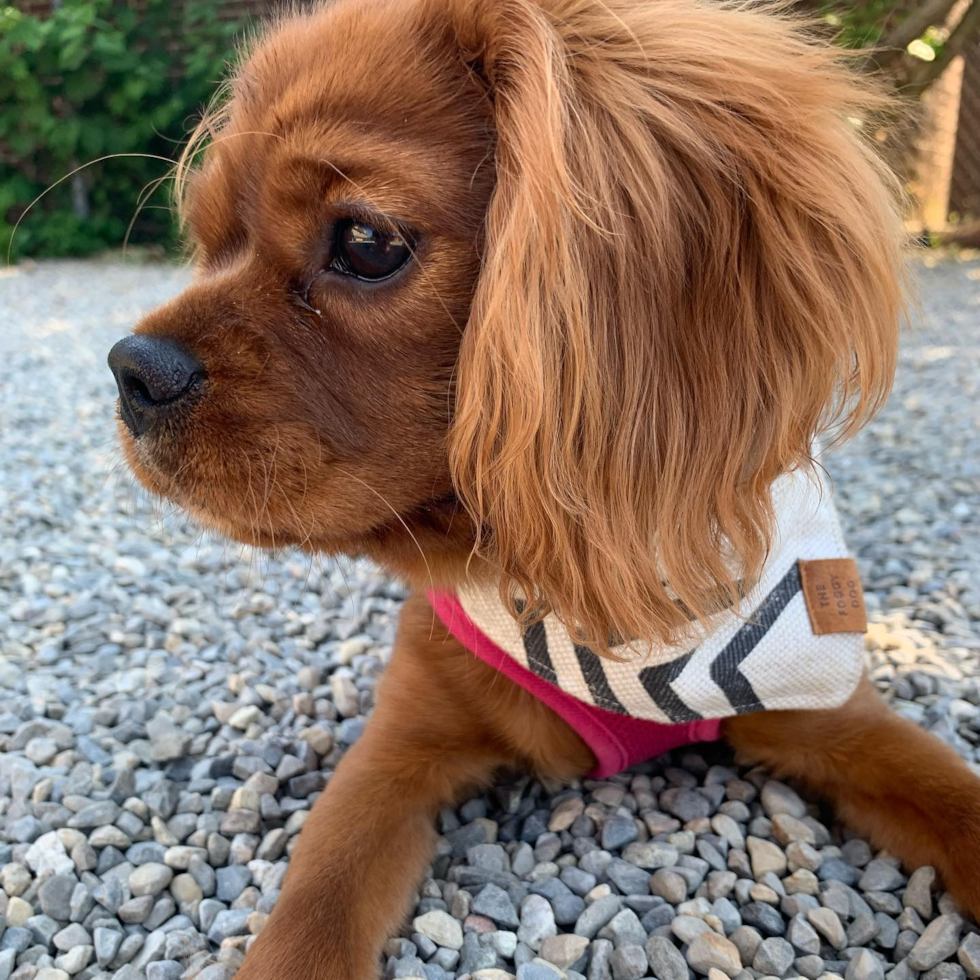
[232,597,576,980]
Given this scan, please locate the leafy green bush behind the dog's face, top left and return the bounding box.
[0,0,251,260]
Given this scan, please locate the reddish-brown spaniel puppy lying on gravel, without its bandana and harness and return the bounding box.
[110,0,980,980]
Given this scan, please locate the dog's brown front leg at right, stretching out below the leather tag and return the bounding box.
[724,680,980,920]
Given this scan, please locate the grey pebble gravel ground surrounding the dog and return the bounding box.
[0,258,980,980]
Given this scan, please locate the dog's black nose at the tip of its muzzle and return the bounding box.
[109,336,204,436]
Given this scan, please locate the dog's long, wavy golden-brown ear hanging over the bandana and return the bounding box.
[450,0,904,653]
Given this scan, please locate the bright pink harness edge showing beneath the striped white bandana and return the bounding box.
[428,591,721,779]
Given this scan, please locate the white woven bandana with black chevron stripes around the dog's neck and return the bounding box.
[459,472,864,723]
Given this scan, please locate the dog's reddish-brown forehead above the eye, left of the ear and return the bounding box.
[189,0,492,253]
